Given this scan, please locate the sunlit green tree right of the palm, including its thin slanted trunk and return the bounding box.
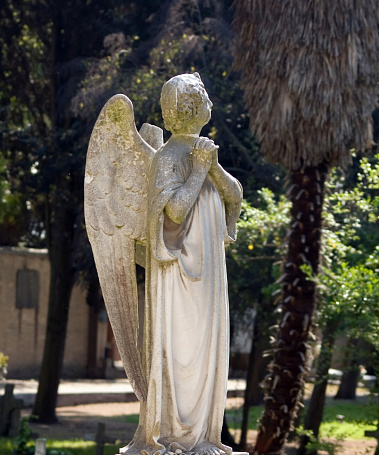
[299,157,379,454]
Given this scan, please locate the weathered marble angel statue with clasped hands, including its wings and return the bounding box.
[85,73,242,455]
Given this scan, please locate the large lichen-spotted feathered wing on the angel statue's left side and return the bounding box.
[84,95,160,401]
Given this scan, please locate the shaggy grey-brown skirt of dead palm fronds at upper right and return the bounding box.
[234,0,379,170]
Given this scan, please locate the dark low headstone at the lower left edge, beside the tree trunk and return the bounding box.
[0,384,24,437]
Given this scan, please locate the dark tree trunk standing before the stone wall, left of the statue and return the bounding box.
[33,203,74,423]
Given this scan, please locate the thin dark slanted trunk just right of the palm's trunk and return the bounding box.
[298,320,339,455]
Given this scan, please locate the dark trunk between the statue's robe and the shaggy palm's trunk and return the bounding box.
[240,314,269,449]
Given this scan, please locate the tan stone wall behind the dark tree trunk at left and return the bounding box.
[0,247,89,378]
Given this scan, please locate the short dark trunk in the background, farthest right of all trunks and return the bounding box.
[334,339,360,400]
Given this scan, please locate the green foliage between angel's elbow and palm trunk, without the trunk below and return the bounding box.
[226,188,289,326]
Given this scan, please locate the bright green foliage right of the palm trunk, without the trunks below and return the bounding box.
[316,155,379,365]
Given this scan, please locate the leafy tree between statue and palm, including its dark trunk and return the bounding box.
[227,194,289,447]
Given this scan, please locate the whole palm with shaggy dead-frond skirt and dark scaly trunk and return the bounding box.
[234,0,379,454]
